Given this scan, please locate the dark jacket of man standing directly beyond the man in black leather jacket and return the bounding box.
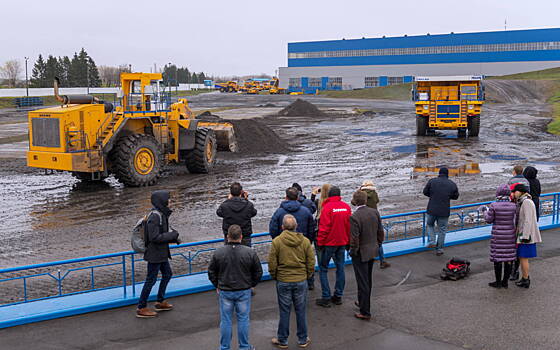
[216,197,257,237]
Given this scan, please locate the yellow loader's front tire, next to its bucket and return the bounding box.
[185,128,217,174]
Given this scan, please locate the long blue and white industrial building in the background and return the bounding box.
[279,28,560,93]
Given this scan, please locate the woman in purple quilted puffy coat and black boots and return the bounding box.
[484,185,517,288]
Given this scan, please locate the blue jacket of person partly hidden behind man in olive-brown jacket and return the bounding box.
[268,200,315,242]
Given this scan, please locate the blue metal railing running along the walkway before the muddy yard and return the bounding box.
[0,192,560,308]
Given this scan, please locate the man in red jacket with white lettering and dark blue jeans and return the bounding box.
[316,186,352,307]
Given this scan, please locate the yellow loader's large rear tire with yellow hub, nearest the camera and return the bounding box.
[109,134,165,187]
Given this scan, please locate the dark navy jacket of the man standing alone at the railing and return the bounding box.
[424,168,459,217]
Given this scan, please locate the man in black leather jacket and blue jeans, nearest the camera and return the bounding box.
[208,225,262,350]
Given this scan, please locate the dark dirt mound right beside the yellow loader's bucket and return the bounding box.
[224,119,289,154]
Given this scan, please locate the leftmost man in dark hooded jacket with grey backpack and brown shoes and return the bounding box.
[136,191,180,318]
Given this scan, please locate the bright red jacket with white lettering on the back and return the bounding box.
[317,196,352,246]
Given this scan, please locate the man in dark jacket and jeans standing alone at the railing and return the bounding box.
[424,168,459,255]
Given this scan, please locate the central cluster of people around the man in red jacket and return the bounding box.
[208,181,384,350]
